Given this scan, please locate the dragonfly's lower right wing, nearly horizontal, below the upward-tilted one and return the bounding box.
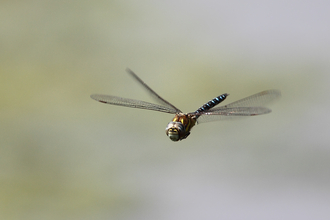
[197,107,272,123]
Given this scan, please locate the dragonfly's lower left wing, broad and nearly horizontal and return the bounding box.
[91,94,177,114]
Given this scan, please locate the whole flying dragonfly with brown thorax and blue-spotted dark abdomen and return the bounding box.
[91,68,281,141]
